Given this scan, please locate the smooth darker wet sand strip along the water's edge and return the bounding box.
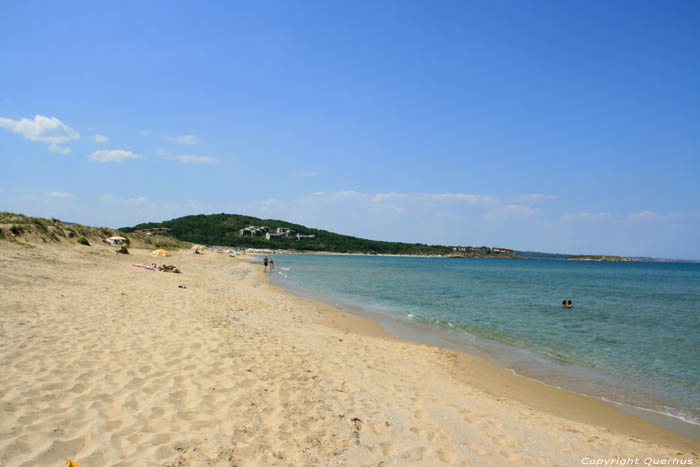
[264,265,700,449]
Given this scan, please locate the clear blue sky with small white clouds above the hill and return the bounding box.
[0,1,700,258]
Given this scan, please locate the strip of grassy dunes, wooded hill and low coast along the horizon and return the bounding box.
[5,212,700,263]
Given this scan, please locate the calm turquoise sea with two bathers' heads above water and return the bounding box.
[272,255,700,432]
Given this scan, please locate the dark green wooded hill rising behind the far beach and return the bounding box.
[119,213,452,255]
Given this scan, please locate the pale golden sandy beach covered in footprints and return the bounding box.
[0,241,700,467]
